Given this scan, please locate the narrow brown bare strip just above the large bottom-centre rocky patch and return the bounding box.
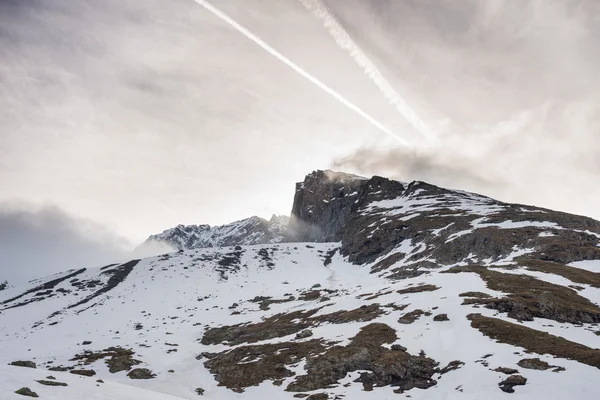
[201,303,385,345]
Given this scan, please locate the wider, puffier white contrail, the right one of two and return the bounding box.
[300,0,433,139]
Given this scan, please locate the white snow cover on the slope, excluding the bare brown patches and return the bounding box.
[0,242,600,400]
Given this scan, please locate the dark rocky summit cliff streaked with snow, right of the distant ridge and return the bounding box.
[288,171,600,275]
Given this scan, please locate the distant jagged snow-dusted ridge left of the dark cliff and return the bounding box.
[141,215,288,251]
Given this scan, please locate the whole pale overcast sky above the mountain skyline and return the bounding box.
[0,0,600,281]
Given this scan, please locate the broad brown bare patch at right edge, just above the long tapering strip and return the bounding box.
[444,266,600,324]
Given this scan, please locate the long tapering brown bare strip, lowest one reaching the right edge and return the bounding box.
[467,314,600,368]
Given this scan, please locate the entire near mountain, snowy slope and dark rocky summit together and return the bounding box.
[0,171,600,400]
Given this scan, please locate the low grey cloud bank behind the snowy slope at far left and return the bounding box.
[0,202,166,285]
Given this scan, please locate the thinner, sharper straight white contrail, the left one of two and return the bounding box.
[194,0,412,147]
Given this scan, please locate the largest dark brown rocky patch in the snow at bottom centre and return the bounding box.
[204,324,437,392]
